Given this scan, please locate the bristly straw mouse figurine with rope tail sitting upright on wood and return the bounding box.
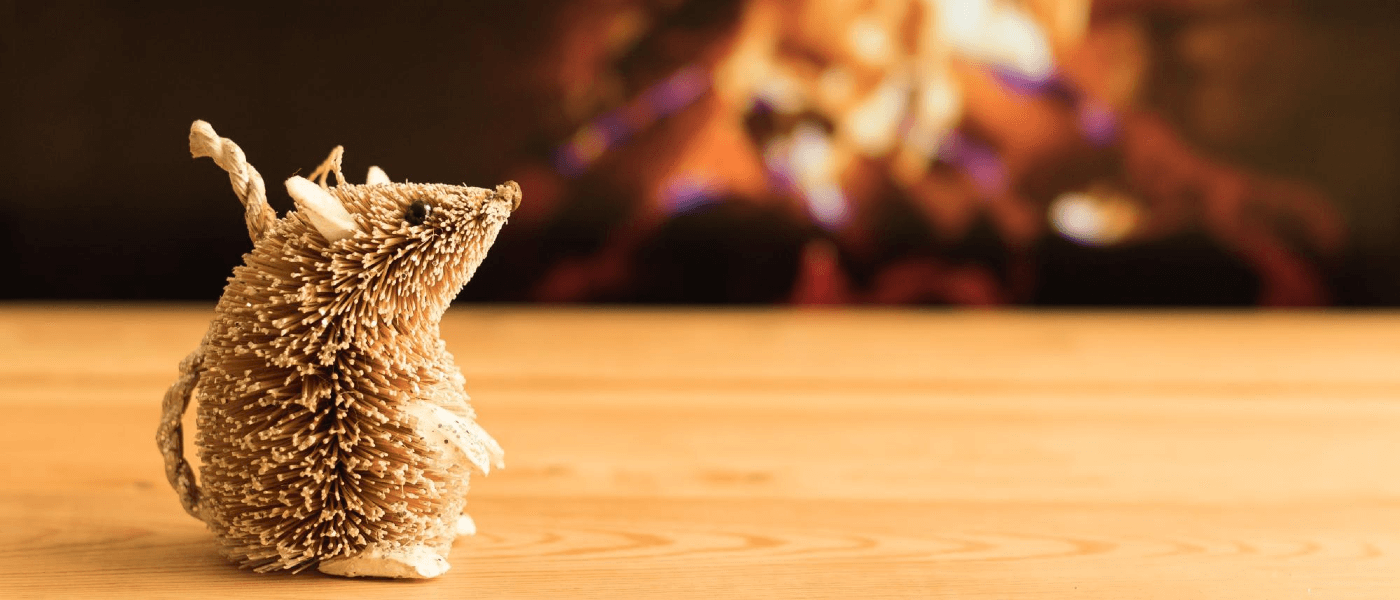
[157,122,521,578]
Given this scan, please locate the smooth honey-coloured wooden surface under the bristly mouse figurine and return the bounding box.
[0,305,1400,600]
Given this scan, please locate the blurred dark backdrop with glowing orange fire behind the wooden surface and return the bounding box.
[0,0,1400,306]
